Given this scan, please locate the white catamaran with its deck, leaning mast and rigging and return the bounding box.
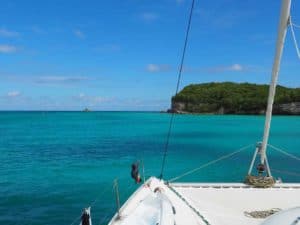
[81,0,300,225]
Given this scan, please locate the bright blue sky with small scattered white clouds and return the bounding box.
[0,0,300,110]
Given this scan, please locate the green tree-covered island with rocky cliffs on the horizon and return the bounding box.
[168,82,300,115]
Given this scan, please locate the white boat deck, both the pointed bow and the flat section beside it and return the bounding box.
[109,178,300,225]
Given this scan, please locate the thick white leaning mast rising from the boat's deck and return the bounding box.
[261,0,291,164]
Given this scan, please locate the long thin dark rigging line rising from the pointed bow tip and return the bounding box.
[159,0,195,179]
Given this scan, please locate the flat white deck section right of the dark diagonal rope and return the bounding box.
[172,183,300,225]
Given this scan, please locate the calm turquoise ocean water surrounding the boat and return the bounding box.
[0,112,300,225]
